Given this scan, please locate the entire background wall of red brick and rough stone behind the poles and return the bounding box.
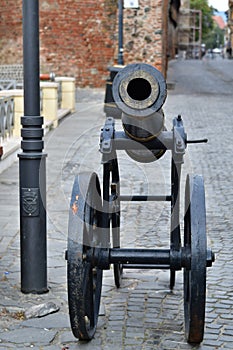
[0,0,173,86]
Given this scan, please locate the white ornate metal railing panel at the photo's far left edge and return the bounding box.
[0,97,14,140]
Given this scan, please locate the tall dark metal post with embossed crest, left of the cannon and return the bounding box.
[18,0,48,294]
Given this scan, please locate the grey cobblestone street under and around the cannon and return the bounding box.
[0,58,233,350]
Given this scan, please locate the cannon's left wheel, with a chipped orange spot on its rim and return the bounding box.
[67,173,103,340]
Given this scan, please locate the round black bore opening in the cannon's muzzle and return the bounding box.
[127,78,151,101]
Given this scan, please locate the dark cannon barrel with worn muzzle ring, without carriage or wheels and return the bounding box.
[112,63,167,162]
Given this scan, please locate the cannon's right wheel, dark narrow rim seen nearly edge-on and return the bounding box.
[184,175,207,343]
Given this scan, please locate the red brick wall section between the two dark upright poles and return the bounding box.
[40,0,117,86]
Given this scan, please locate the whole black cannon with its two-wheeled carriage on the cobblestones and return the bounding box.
[66,63,214,343]
